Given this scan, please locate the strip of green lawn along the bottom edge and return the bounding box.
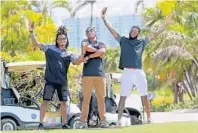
[4,122,198,133]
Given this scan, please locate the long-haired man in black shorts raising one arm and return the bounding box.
[29,21,84,129]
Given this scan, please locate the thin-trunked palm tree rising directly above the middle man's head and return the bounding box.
[71,0,96,26]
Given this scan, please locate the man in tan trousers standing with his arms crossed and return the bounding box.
[81,27,108,128]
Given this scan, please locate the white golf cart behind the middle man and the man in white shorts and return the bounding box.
[79,73,143,127]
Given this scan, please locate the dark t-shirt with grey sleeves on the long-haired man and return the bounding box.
[40,44,77,85]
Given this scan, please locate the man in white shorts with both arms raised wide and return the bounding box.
[101,8,172,126]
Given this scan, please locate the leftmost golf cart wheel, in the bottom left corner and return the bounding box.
[1,118,17,131]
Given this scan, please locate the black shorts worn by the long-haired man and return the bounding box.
[43,82,68,101]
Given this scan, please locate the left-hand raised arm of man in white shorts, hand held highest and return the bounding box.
[101,7,120,42]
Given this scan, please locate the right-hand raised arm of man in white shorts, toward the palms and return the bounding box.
[148,14,173,42]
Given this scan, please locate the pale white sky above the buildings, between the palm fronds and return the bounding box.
[52,0,156,25]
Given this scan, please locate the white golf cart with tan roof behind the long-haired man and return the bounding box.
[0,62,81,131]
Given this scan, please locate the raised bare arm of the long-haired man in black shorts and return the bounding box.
[28,21,41,48]
